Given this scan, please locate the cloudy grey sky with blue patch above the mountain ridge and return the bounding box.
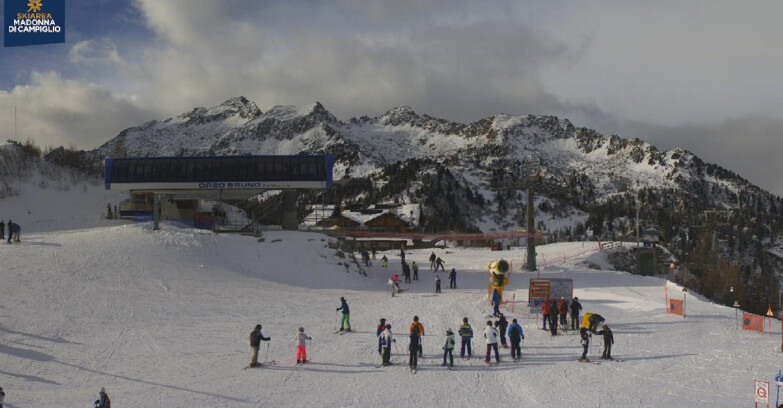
[0,0,783,195]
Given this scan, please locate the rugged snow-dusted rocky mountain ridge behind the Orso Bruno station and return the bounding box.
[91,97,758,204]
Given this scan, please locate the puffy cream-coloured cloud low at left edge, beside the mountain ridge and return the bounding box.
[0,72,154,148]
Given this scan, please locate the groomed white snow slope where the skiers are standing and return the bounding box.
[0,223,781,408]
